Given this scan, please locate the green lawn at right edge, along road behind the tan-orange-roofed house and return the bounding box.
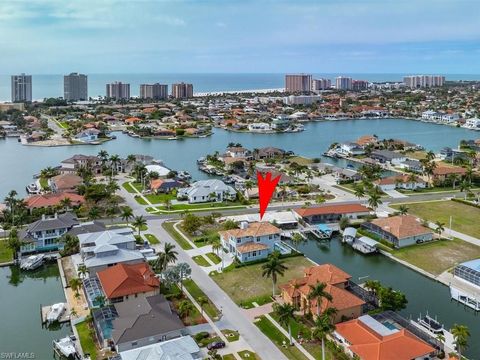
[391,200,480,238]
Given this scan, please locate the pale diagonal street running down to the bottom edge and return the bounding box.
[148,219,287,360]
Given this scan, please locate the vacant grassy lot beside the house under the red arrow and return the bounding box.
[212,256,313,306]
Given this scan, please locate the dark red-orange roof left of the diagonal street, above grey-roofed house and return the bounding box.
[97,263,160,299]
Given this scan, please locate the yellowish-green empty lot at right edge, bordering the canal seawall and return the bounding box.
[391,238,480,275]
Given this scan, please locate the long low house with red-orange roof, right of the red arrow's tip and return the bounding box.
[294,204,370,224]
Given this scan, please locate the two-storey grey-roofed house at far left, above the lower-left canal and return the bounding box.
[20,213,79,254]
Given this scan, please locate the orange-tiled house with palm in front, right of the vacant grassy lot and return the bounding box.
[280,264,365,323]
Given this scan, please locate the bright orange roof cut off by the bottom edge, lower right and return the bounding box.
[336,319,435,360]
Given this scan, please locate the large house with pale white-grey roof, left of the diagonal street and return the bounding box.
[77,228,145,275]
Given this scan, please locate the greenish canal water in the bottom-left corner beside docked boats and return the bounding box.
[0,265,71,360]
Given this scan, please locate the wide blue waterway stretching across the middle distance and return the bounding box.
[0,119,479,199]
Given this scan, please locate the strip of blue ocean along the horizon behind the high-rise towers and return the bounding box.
[0,73,480,101]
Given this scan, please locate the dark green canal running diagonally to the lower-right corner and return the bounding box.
[298,237,480,360]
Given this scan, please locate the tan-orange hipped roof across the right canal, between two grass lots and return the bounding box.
[372,215,432,239]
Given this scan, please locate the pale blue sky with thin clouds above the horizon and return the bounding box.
[0,0,480,74]
